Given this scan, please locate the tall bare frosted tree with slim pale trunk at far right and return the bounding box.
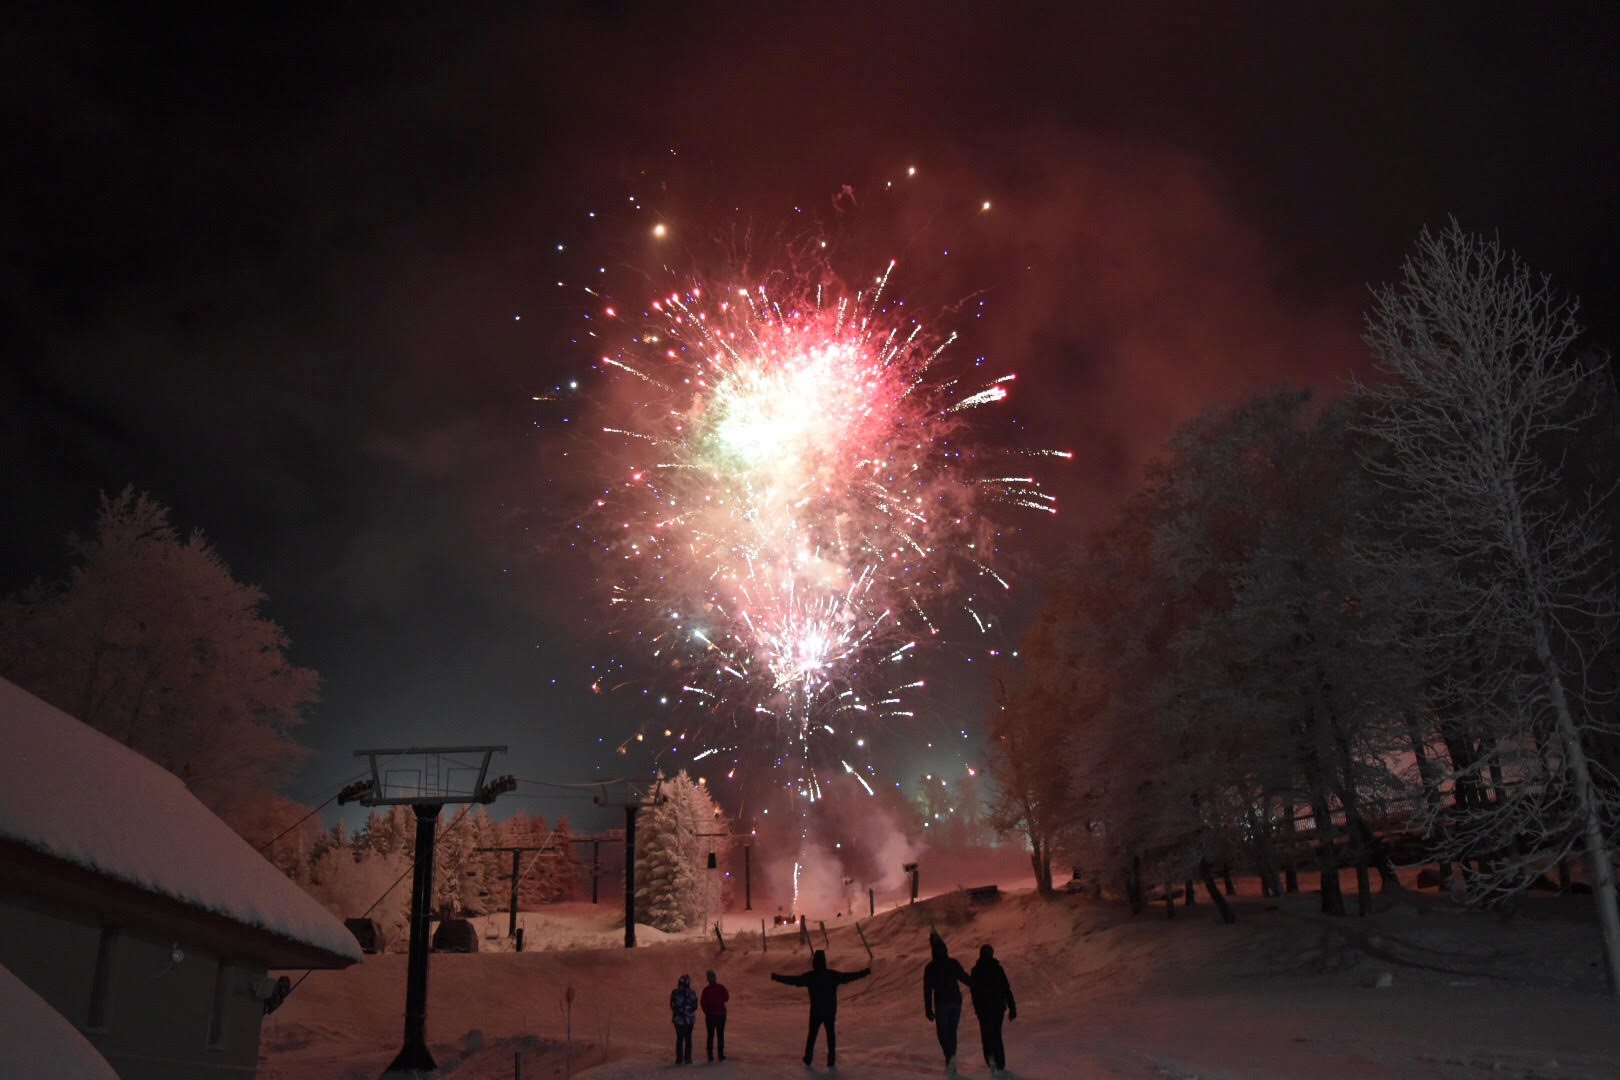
[1358,220,1620,991]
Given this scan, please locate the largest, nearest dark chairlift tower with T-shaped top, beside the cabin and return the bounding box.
[348,746,517,1080]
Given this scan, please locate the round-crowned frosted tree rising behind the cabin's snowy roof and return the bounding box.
[0,487,316,829]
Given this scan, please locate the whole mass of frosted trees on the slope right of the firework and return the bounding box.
[988,222,1620,986]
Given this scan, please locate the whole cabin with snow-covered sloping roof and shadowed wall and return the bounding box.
[0,678,361,1080]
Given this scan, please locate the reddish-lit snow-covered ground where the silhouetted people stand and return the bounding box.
[259,894,1620,1080]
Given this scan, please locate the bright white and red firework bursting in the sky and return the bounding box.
[588,254,1068,800]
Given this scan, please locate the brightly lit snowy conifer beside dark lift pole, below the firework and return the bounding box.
[635,771,729,931]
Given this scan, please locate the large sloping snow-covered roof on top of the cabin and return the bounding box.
[0,678,361,960]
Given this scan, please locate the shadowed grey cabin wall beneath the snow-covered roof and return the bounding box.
[0,897,264,1080]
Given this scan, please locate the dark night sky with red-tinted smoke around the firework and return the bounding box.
[0,3,1620,829]
